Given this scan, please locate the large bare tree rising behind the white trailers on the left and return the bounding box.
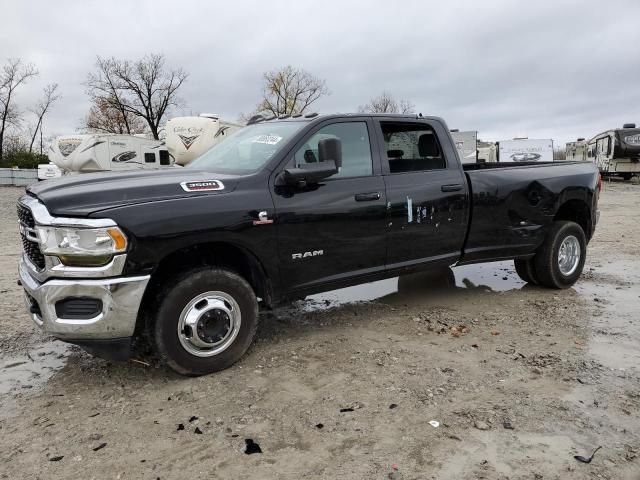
[86,54,187,139]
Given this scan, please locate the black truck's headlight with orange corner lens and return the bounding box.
[37,226,127,267]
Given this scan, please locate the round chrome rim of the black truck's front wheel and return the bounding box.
[178,292,241,357]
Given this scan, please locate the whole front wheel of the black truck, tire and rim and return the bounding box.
[150,268,258,376]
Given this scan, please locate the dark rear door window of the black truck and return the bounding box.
[380,122,447,173]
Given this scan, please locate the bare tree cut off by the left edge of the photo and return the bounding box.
[0,58,38,158]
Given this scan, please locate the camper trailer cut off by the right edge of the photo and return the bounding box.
[587,123,640,180]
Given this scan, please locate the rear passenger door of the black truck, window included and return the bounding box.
[376,117,468,268]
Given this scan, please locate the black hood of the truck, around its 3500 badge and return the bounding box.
[27,168,241,217]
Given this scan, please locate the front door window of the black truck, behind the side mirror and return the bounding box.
[294,122,373,178]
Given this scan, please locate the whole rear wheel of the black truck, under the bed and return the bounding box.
[534,221,587,289]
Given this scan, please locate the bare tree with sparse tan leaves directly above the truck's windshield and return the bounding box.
[256,65,329,116]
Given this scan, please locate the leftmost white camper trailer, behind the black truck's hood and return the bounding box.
[49,134,174,173]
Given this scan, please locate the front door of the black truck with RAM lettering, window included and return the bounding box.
[271,117,387,291]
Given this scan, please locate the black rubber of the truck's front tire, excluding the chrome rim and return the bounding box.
[149,267,258,376]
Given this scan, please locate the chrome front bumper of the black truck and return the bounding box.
[19,258,150,340]
